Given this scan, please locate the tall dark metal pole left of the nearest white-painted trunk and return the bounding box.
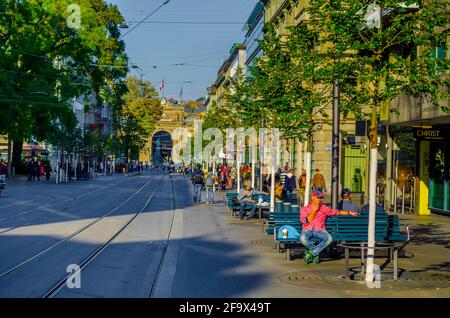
[331,76,340,209]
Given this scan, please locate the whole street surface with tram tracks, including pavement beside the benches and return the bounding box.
[0,170,448,298]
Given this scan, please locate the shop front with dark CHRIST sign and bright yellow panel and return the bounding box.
[384,89,450,215]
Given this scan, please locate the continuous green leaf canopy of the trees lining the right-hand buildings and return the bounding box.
[218,0,450,144]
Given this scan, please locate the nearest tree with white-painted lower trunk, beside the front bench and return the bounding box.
[308,0,450,282]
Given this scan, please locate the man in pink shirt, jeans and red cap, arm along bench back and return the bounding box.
[300,190,359,264]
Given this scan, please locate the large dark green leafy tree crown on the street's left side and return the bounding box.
[0,0,127,170]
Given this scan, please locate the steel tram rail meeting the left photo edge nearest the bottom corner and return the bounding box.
[0,175,158,283]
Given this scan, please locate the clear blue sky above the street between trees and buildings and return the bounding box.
[107,0,258,100]
